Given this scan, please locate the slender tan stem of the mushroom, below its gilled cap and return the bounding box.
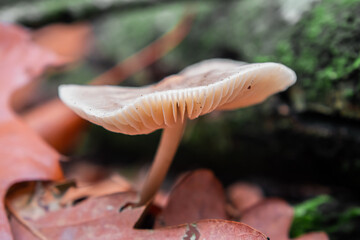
[136,120,186,206]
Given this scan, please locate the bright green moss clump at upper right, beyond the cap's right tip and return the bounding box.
[257,0,360,116]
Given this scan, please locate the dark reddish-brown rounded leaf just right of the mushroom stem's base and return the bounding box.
[155,170,227,227]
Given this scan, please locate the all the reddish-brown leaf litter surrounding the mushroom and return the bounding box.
[0,12,328,240]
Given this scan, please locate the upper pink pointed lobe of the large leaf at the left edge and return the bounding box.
[0,23,60,112]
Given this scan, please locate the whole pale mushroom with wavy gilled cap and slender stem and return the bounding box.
[59,59,296,206]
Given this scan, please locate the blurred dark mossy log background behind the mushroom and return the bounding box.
[0,0,360,239]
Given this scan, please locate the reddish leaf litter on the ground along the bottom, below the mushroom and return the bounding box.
[8,169,328,240]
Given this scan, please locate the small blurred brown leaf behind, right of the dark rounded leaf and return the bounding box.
[227,182,264,213]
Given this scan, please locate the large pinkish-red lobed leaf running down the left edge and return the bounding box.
[0,24,62,240]
